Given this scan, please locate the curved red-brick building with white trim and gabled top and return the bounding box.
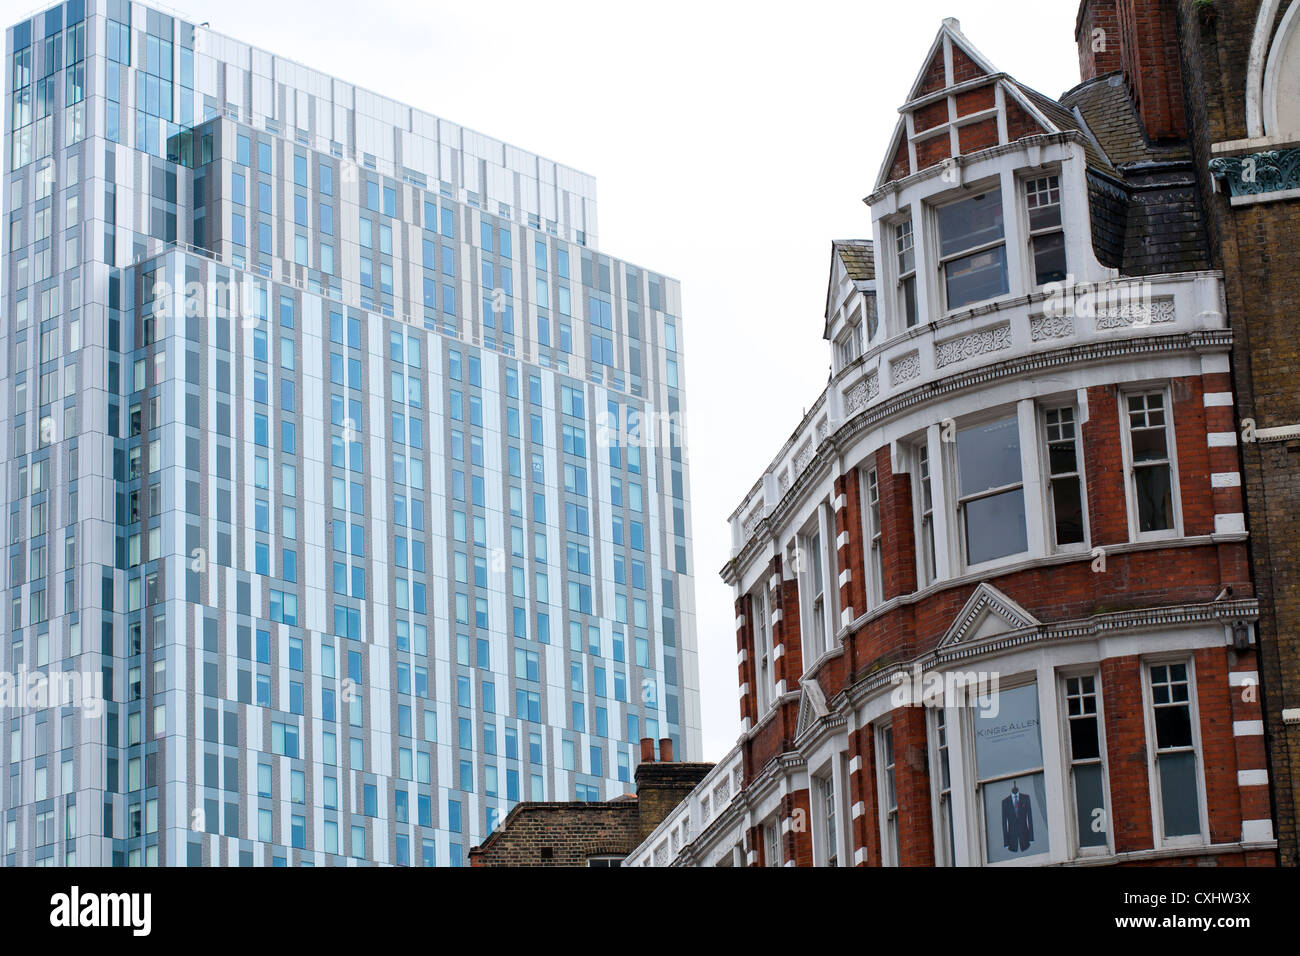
[628,13,1279,866]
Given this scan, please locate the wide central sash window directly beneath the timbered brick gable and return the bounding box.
[937,189,1009,311]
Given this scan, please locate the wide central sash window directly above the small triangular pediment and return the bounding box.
[957,415,1030,564]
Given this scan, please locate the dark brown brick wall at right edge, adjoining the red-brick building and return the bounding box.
[1177,0,1300,866]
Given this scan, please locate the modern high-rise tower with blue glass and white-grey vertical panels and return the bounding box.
[0,0,701,866]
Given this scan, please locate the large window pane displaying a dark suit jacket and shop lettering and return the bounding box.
[974,684,1050,864]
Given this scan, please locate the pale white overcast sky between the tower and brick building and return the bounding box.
[0,0,1079,760]
